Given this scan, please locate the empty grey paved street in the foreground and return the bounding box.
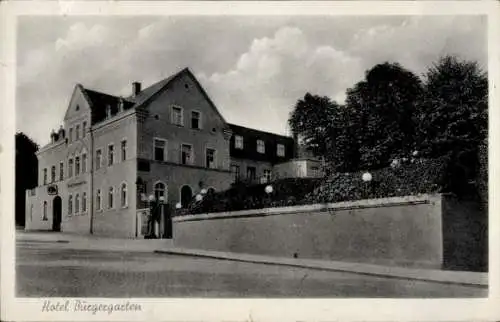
[16,240,487,297]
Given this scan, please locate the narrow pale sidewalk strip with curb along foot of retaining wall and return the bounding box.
[153,250,488,288]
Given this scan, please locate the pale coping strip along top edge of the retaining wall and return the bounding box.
[172,194,442,222]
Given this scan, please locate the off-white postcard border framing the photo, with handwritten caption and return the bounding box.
[0,1,500,321]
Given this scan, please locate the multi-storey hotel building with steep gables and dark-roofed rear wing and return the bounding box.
[25,69,322,238]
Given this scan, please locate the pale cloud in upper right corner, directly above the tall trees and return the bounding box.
[349,16,487,74]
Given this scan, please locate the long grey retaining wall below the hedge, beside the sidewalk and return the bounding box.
[174,195,486,268]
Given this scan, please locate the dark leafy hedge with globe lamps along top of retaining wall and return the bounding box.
[181,159,446,215]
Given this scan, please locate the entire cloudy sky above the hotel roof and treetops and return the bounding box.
[16,16,487,144]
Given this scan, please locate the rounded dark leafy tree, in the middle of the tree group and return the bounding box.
[346,62,422,169]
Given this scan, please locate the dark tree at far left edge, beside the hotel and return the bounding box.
[15,132,38,226]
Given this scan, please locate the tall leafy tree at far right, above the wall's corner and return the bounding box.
[417,56,488,195]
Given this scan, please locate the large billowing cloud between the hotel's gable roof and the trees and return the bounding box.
[199,27,362,133]
